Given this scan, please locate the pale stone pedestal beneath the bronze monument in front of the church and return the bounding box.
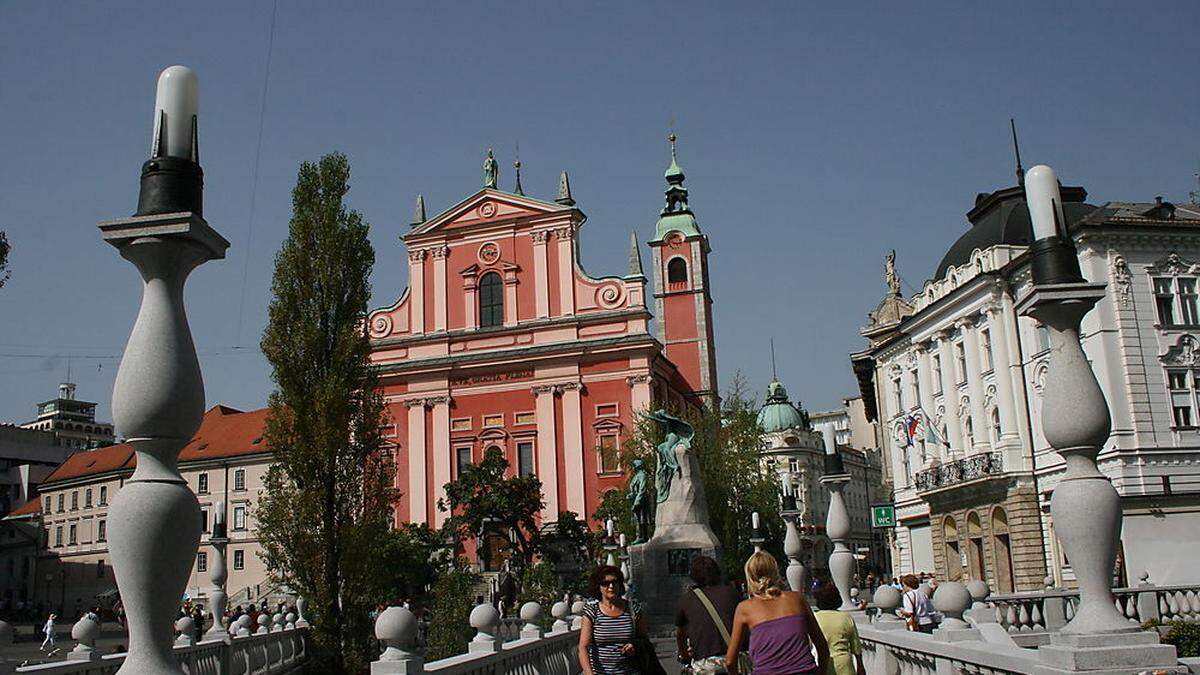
[629,443,715,637]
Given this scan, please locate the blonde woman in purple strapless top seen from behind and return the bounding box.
[725,551,829,675]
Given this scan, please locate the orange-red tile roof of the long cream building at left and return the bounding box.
[40,405,269,482]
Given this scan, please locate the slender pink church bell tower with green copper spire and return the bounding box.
[649,133,720,401]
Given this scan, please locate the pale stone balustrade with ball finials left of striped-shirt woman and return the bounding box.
[371,602,581,675]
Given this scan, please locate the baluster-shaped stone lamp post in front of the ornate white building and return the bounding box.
[1018,165,1176,671]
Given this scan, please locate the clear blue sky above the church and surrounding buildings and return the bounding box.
[0,0,1200,422]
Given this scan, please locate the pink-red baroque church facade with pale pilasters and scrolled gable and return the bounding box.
[367,148,715,526]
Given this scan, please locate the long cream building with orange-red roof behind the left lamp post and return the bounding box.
[7,406,276,616]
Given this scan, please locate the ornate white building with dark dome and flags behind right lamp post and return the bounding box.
[851,173,1200,592]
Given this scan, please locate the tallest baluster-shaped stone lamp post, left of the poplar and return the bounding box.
[100,66,229,675]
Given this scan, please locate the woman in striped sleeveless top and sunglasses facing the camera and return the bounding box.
[580,565,646,675]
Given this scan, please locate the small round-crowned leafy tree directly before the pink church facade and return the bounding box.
[438,448,545,573]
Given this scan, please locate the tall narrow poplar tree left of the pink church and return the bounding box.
[256,153,394,673]
